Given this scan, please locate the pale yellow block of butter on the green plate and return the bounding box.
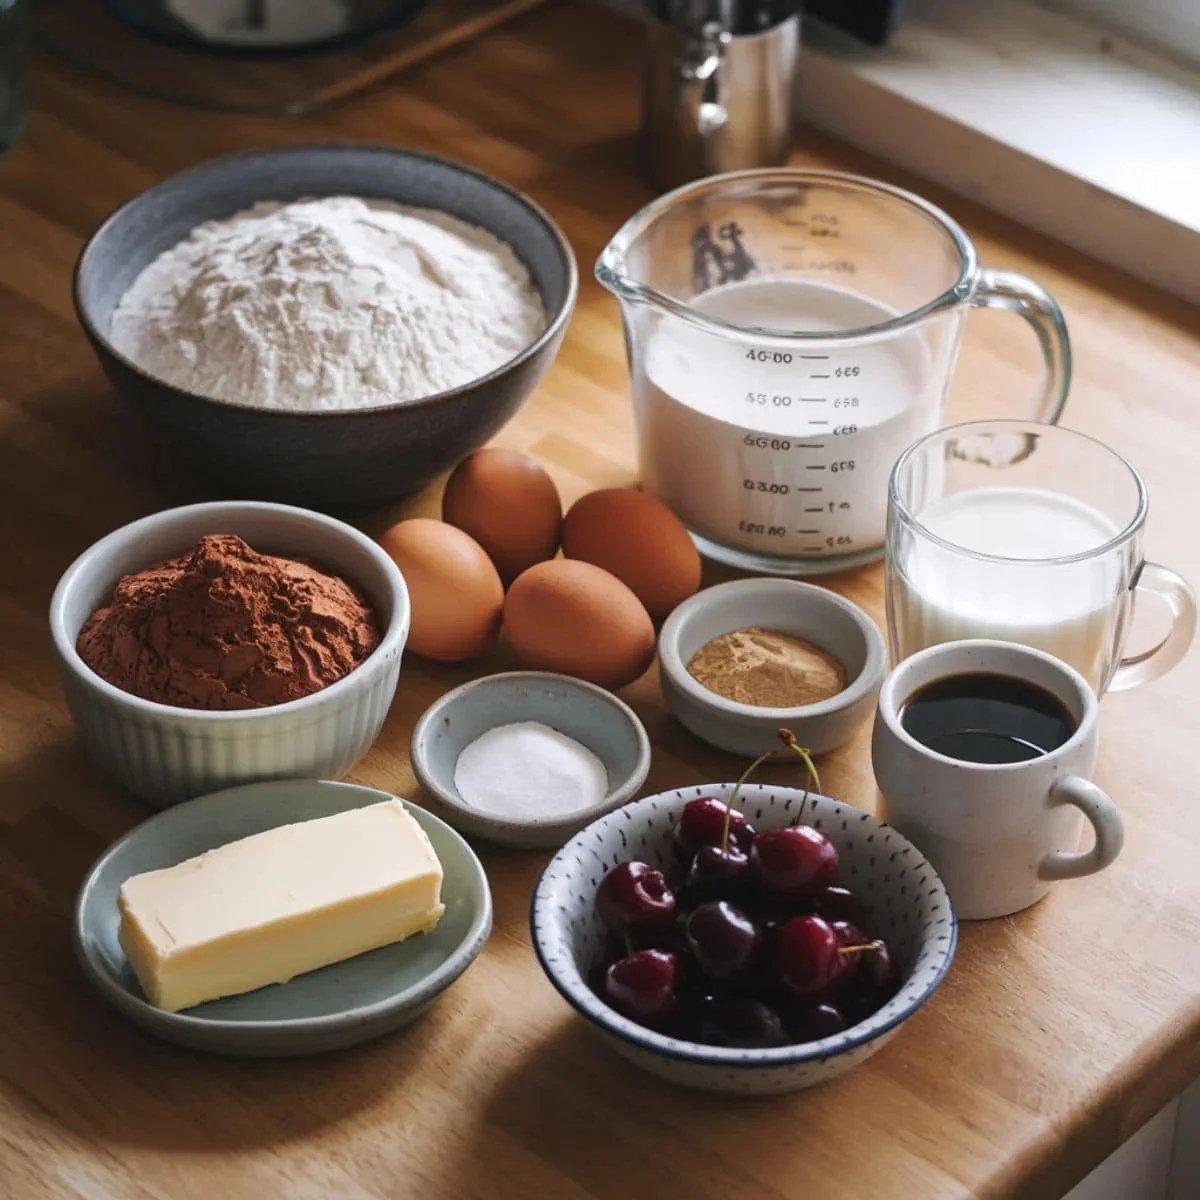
[118,800,445,1013]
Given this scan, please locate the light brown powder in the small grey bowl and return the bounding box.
[688,629,846,708]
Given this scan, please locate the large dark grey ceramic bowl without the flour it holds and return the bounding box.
[74,144,578,506]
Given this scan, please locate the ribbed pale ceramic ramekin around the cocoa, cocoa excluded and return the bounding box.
[50,500,410,806]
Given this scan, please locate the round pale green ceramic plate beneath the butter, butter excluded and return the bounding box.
[74,780,492,1057]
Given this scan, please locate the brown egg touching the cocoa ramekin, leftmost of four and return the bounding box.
[379,517,504,662]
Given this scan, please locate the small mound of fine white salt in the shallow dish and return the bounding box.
[454,721,608,821]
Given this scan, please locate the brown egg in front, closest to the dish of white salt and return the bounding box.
[504,558,654,688]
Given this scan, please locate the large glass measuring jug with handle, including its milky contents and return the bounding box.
[596,168,1070,575]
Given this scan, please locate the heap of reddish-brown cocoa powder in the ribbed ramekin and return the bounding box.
[77,534,379,709]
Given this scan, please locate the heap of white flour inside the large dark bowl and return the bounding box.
[110,196,546,412]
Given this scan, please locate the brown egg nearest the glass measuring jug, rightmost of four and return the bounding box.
[563,487,700,620]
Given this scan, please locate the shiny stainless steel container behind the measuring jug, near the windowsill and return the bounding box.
[642,0,800,188]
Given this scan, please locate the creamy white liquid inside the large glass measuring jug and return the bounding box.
[634,278,944,559]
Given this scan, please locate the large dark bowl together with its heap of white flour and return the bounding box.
[74,144,578,506]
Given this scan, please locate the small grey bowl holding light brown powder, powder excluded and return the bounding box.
[659,580,887,758]
